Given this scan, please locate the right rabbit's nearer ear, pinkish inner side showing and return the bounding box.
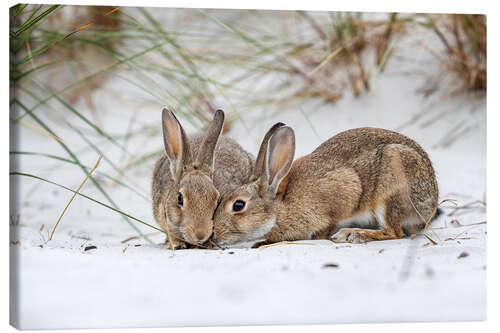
[266,126,295,195]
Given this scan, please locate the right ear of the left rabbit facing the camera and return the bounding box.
[195,110,224,173]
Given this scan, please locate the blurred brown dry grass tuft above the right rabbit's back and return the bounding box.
[289,12,403,102]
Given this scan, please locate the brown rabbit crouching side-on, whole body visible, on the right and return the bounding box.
[213,123,438,246]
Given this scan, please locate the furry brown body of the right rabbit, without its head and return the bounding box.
[269,128,438,242]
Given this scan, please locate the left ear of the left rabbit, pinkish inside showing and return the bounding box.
[162,109,191,181]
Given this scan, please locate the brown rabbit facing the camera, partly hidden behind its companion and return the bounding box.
[152,109,254,249]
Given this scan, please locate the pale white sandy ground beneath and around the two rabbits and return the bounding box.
[10,10,487,329]
